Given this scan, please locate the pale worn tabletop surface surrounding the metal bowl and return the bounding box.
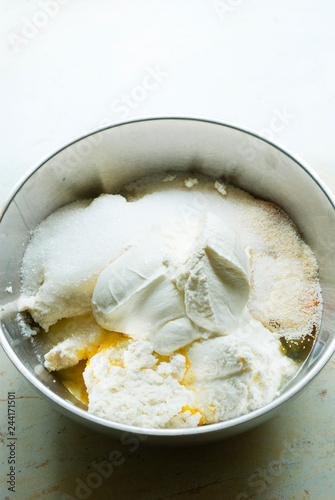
[0,0,335,500]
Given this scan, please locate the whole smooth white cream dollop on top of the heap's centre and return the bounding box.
[92,213,249,354]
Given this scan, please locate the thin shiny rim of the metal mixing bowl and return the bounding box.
[0,115,335,437]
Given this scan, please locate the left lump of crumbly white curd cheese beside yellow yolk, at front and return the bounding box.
[84,340,201,427]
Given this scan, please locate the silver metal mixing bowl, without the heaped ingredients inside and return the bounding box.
[0,118,335,444]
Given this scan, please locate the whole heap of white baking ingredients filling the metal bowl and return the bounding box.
[20,174,322,428]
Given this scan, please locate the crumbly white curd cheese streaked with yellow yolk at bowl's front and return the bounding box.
[84,320,296,427]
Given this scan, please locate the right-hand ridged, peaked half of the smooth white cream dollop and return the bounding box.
[178,212,250,334]
